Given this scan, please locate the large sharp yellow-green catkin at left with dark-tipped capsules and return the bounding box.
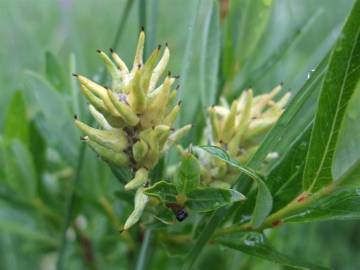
[74,30,190,229]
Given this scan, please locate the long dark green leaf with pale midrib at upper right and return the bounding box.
[303,1,360,191]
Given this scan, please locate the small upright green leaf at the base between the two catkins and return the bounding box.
[174,153,200,194]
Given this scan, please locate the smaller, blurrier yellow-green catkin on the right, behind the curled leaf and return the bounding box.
[199,84,290,187]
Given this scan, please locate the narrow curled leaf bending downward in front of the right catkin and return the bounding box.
[201,146,272,228]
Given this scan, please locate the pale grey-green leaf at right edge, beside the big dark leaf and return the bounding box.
[332,80,360,181]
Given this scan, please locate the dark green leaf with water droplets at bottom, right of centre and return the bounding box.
[218,232,328,270]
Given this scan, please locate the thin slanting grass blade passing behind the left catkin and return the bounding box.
[56,0,133,270]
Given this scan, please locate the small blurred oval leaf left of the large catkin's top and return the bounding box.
[45,52,65,91]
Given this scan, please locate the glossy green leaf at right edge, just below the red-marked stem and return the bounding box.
[283,188,360,222]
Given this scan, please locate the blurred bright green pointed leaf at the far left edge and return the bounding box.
[4,91,29,144]
